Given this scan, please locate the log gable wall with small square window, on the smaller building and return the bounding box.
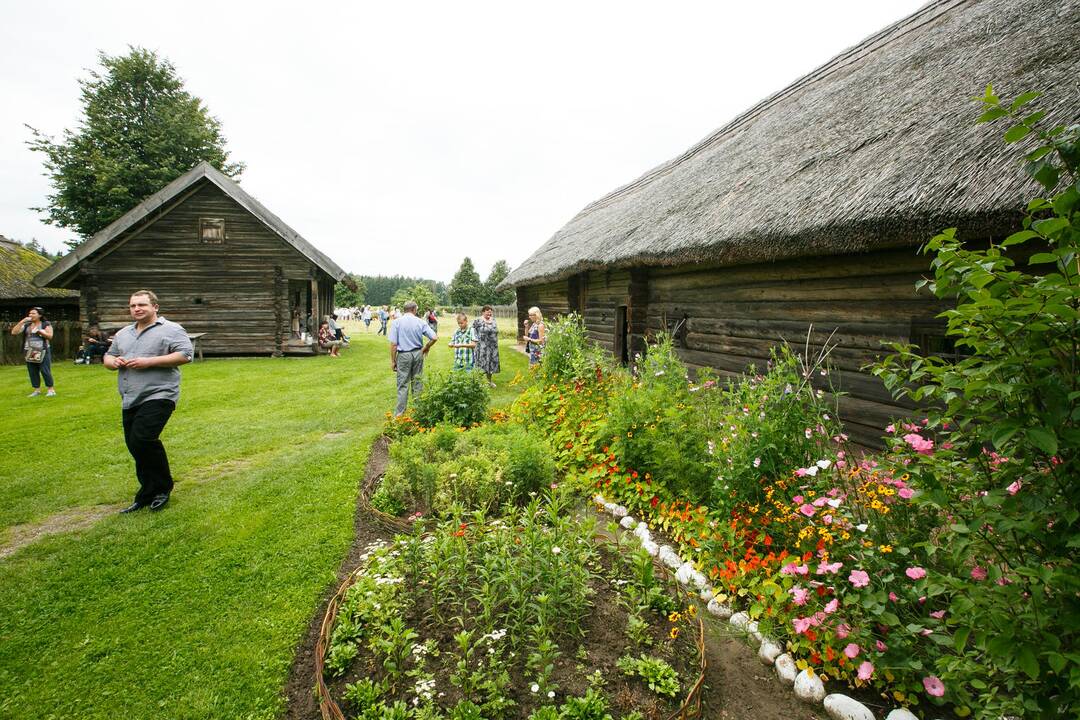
[80,182,334,354]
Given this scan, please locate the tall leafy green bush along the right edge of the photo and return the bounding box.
[875,87,1080,717]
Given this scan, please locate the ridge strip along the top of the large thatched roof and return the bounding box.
[570,0,972,222]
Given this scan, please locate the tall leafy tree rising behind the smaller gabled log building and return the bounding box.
[27,47,244,247]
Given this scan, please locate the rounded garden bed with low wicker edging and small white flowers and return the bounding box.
[320,493,704,720]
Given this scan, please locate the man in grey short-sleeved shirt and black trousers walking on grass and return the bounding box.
[105,290,192,513]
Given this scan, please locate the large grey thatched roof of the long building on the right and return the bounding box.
[502,0,1080,287]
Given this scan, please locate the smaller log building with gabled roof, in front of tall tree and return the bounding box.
[35,162,347,355]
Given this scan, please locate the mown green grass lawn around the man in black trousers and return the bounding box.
[0,330,526,719]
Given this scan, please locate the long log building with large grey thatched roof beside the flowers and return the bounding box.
[501,0,1080,445]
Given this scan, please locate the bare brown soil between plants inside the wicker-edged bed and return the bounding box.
[327,551,708,720]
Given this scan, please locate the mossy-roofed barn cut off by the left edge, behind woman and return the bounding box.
[0,235,79,322]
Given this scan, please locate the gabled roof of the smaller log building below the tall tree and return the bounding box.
[33,162,346,287]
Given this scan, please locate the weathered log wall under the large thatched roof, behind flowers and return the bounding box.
[517,249,949,446]
